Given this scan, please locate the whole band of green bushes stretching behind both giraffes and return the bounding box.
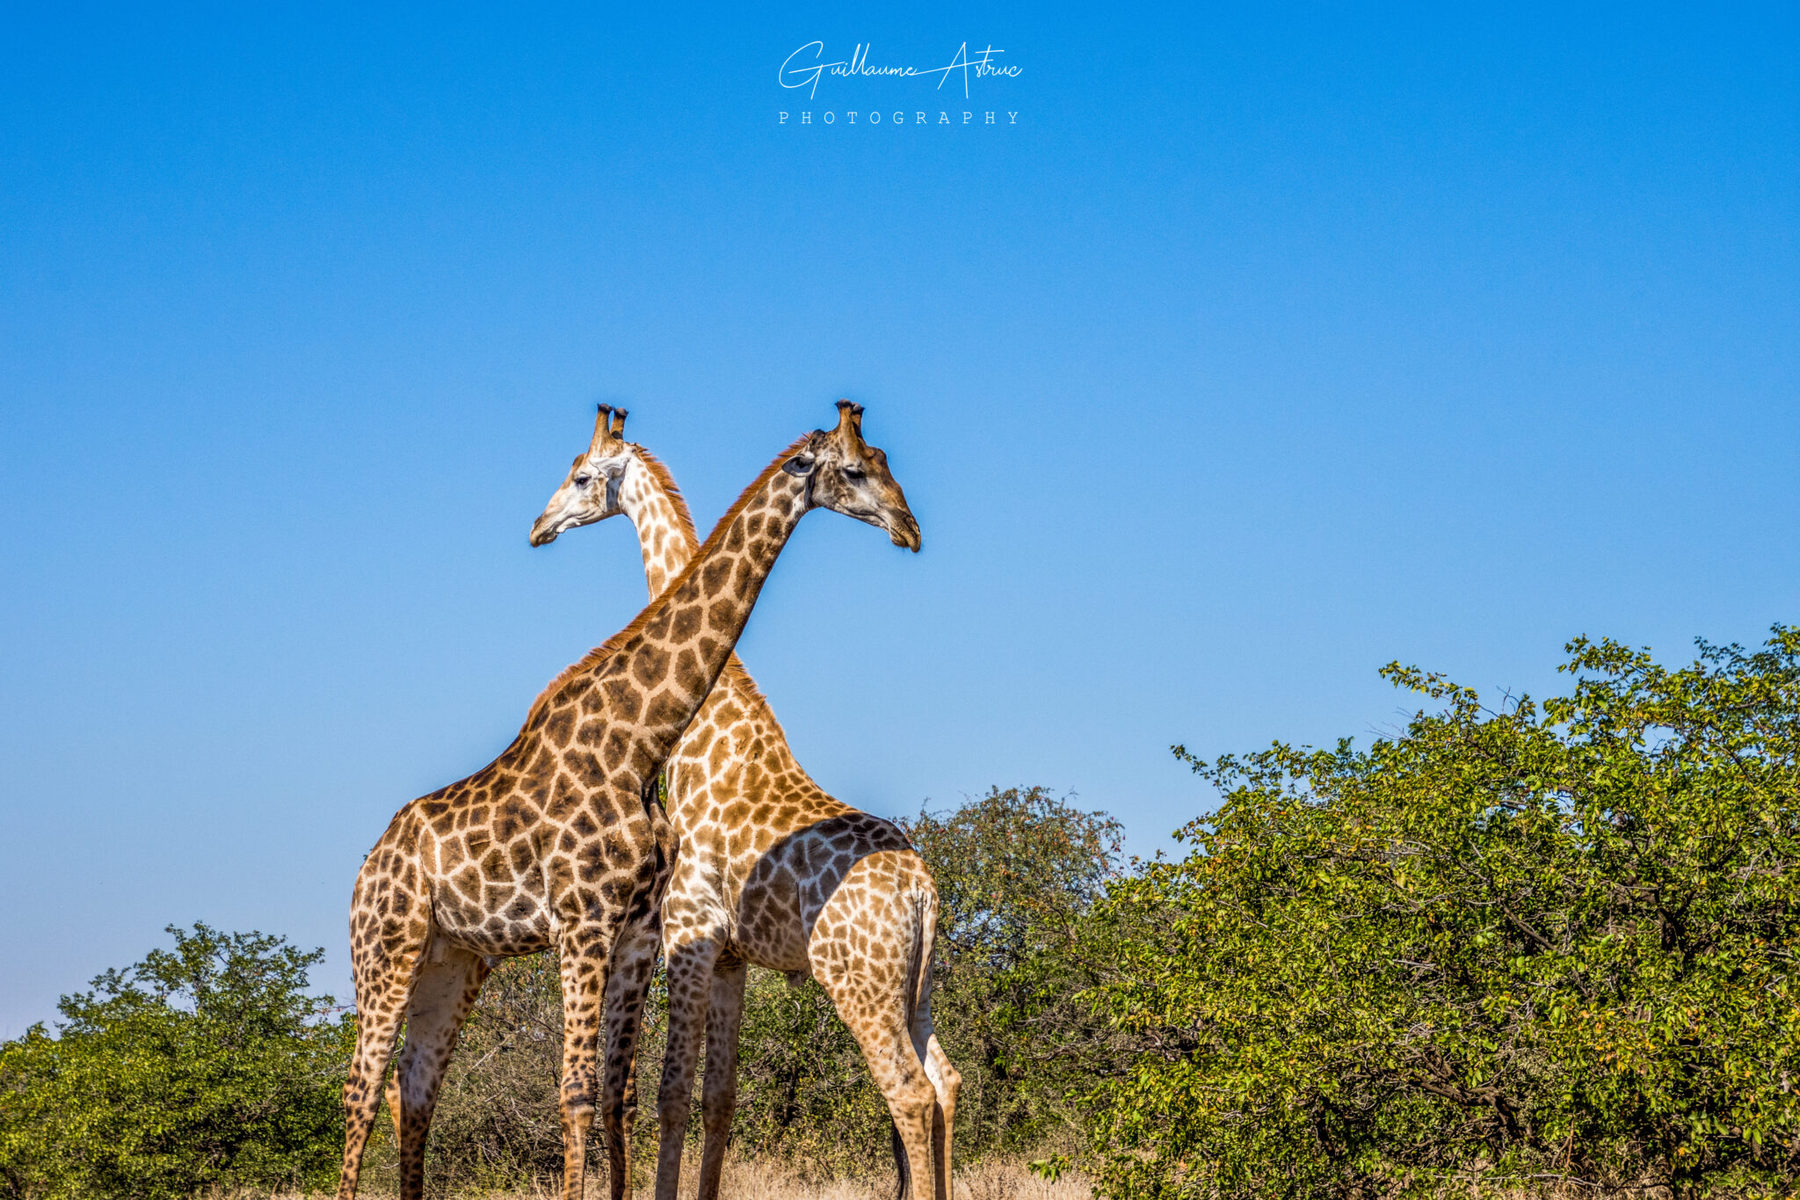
[0,626,1800,1200]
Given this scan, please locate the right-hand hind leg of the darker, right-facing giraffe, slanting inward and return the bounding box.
[387,941,490,1200]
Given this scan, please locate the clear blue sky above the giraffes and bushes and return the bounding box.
[0,5,1800,1034]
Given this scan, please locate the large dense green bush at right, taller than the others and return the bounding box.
[1091,626,1800,1196]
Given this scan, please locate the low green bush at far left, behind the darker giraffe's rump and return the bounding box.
[0,925,355,1200]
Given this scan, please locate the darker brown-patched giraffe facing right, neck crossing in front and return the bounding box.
[338,406,920,1200]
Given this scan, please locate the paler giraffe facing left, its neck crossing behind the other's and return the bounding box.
[531,401,961,1200]
